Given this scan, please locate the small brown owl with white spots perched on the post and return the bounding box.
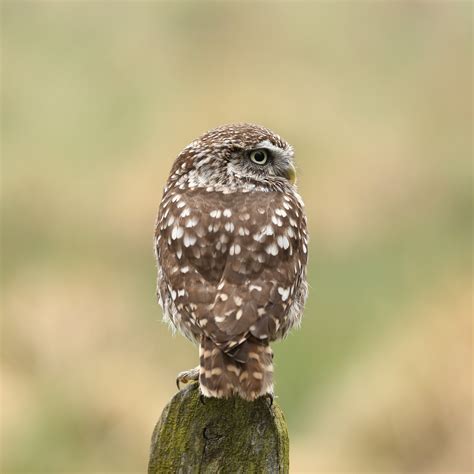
[155,123,308,400]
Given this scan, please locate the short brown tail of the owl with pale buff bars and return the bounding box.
[199,338,273,400]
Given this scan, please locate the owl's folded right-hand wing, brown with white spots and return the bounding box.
[208,192,306,349]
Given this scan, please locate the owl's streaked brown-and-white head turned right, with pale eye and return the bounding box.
[170,123,295,192]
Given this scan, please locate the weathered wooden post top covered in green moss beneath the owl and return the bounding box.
[148,383,289,474]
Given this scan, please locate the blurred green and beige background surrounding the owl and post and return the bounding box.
[1,1,473,473]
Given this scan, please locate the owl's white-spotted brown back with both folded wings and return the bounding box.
[159,190,307,352]
